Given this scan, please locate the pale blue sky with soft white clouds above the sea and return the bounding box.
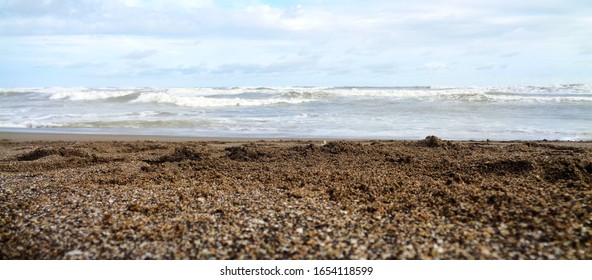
[0,0,592,87]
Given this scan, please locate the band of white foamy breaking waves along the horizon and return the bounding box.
[5,85,592,104]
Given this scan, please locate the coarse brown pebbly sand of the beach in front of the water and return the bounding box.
[0,134,592,259]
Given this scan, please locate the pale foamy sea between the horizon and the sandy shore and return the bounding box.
[0,84,592,140]
